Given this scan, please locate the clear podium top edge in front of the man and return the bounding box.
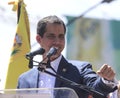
[0,88,78,98]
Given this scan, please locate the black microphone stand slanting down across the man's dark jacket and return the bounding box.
[38,57,107,98]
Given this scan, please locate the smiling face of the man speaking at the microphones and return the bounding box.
[37,24,65,60]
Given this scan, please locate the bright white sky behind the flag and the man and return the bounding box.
[0,0,120,89]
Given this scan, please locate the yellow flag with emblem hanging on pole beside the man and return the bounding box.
[5,0,31,89]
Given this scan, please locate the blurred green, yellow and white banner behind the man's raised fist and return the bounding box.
[66,16,120,79]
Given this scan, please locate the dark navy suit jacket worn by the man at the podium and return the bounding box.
[17,57,113,98]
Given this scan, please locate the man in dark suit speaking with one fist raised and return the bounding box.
[17,16,115,98]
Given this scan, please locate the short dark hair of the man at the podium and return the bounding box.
[37,15,66,37]
